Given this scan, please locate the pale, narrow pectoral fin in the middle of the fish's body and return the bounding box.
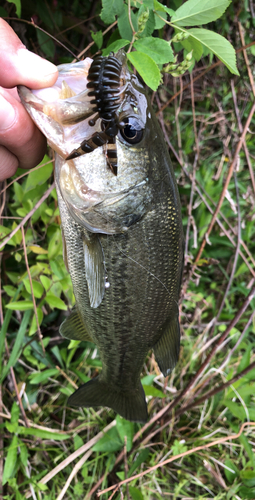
[83,231,105,308]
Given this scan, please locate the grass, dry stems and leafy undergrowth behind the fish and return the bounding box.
[0,0,255,500]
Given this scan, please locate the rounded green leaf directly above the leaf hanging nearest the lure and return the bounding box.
[134,36,174,64]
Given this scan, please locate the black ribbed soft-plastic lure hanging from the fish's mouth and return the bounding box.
[66,55,124,175]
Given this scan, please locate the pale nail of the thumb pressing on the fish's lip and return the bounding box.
[18,49,57,80]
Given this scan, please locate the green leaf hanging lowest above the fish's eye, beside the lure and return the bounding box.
[127,52,161,90]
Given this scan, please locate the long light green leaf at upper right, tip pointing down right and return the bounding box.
[187,28,239,75]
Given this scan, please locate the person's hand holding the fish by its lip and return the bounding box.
[0,19,58,181]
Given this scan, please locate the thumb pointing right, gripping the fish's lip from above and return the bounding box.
[0,19,58,89]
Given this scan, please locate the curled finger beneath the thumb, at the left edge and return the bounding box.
[0,89,46,173]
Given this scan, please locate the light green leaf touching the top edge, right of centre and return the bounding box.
[171,0,231,26]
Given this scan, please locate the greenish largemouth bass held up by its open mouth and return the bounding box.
[18,50,184,422]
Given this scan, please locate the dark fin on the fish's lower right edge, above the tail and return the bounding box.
[153,315,180,377]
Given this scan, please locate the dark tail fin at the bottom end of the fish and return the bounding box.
[68,377,148,422]
